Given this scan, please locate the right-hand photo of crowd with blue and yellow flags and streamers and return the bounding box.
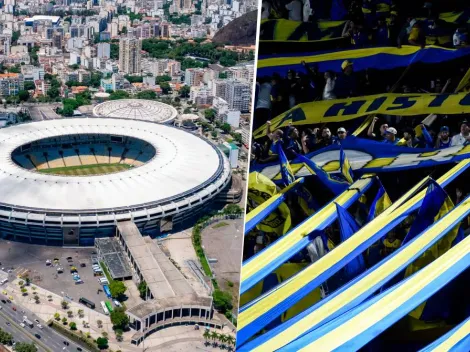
[242,0,470,352]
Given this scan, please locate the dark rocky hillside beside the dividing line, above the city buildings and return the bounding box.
[212,11,258,45]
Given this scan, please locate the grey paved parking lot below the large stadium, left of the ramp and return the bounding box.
[0,240,106,304]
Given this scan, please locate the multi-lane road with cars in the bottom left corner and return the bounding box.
[0,294,87,352]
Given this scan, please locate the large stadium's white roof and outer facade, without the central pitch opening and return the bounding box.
[0,118,231,246]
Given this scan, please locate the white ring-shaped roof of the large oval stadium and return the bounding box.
[0,118,226,212]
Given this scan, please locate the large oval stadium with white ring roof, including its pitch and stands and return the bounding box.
[0,118,231,245]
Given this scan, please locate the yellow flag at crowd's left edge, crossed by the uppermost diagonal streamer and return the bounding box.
[246,172,291,236]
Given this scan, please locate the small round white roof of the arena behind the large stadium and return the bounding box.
[93,99,178,123]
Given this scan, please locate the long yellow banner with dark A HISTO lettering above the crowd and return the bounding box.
[253,93,470,138]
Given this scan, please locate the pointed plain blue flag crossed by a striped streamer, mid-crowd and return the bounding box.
[335,203,366,280]
